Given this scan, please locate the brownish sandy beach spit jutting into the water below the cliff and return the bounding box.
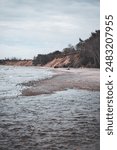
[22,68,100,96]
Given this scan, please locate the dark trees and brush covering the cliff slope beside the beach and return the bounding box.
[33,30,100,68]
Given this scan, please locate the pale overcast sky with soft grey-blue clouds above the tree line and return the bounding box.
[0,0,100,59]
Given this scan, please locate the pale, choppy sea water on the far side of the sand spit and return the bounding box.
[0,66,55,97]
